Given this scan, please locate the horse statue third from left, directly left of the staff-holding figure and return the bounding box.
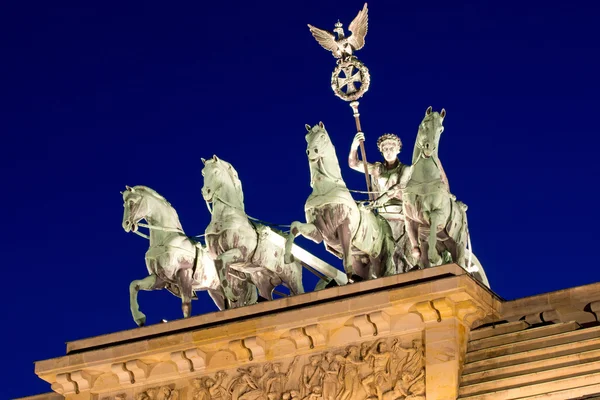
[286,122,397,280]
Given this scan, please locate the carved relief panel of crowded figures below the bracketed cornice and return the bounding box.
[185,336,425,400]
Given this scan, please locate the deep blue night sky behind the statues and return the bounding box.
[0,0,600,398]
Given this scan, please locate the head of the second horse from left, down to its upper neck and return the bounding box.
[202,155,244,204]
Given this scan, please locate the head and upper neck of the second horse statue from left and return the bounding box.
[202,155,244,208]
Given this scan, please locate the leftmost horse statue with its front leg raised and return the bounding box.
[122,186,257,326]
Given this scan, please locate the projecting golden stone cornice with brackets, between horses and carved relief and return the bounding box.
[36,265,500,394]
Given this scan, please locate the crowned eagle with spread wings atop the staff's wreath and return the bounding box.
[308,3,368,60]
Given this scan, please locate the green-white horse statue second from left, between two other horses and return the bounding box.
[202,156,304,302]
